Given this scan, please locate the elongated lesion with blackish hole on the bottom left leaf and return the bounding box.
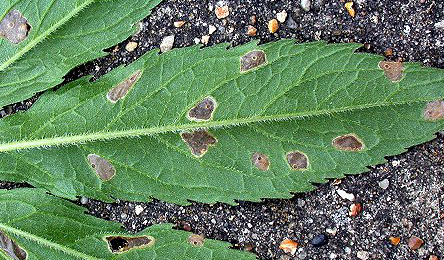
[105,236,155,253]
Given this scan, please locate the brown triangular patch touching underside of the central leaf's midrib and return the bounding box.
[181,130,217,157]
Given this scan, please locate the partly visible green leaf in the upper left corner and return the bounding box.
[0,0,161,107]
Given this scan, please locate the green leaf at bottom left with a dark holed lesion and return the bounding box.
[0,188,256,260]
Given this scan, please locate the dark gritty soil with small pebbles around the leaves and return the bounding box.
[0,0,444,259]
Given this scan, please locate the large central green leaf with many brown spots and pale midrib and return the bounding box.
[0,40,444,204]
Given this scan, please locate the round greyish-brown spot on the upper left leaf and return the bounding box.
[0,10,31,44]
